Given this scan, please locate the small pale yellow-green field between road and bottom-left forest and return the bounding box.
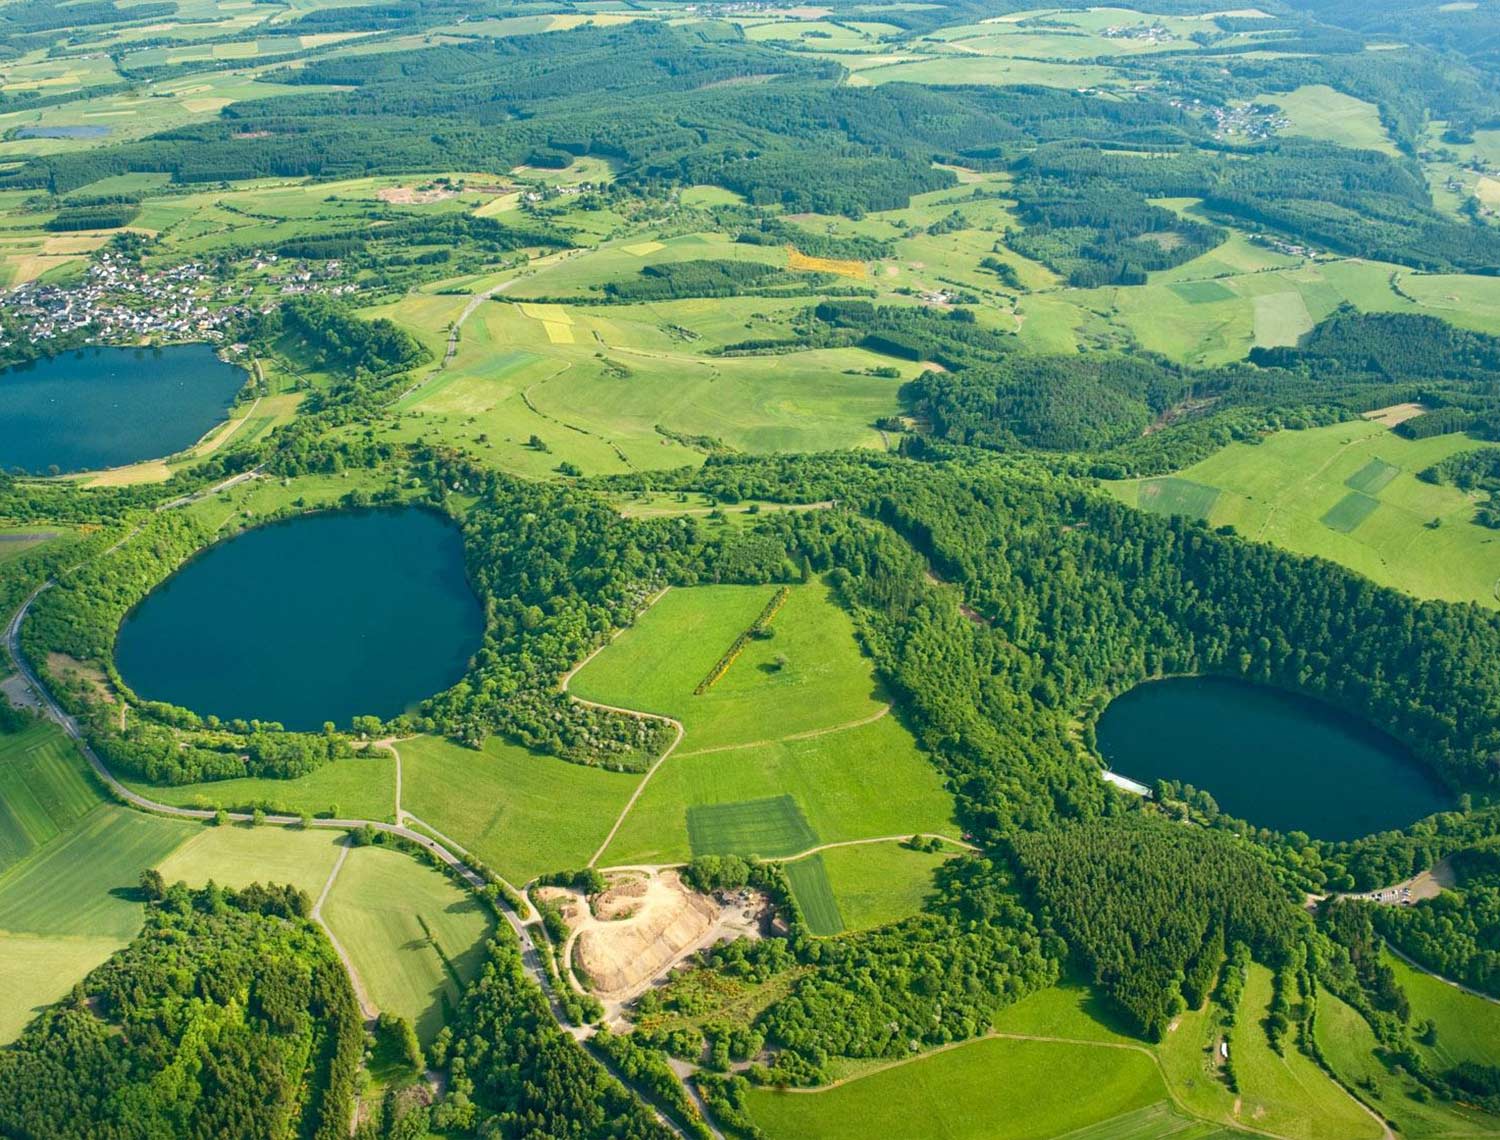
[158,824,344,902]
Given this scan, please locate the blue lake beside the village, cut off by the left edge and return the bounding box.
[0,345,246,474]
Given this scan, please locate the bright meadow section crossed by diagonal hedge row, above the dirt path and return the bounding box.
[572,582,885,755]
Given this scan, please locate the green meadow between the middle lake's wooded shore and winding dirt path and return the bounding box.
[399,737,641,884]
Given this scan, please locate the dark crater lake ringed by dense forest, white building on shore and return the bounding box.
[1097,677,1452,840]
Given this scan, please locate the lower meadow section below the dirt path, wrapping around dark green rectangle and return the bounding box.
[600,711,956,867]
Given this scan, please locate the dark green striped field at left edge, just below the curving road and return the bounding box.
[0,722,101,872]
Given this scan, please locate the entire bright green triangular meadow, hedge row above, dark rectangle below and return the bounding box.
[572,582,954,866]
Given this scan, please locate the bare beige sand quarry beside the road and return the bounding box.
[543,867,768,1004]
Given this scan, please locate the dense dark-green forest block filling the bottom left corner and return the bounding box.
[0,875,365,1140]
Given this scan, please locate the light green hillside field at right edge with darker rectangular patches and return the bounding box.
[1107,420,1500,606]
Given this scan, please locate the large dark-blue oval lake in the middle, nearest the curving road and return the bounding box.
[116,507,485,731]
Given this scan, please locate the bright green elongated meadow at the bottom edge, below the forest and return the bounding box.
[750,1038,1167,1140]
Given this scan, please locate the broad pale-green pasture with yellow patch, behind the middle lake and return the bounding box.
[387,299,917,477]
